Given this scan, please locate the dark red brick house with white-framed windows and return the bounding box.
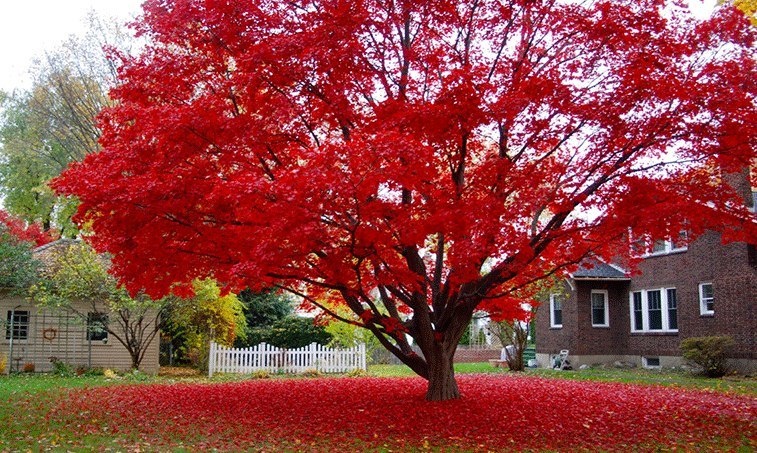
[536,182,757,373]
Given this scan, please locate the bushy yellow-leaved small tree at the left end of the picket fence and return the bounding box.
[164,279,247,371]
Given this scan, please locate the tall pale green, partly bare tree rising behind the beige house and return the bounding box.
[0,15,131,237]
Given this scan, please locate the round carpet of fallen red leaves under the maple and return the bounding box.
[48,375,757,451]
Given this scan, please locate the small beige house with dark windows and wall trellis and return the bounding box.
[0,241,160,373]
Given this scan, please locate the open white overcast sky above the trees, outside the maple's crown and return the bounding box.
[0,0,716,92]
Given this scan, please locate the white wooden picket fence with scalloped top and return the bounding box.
[208,342,365,377]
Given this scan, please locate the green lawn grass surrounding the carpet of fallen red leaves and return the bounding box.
[0,363,757,452]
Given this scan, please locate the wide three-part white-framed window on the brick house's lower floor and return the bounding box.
[630,288,678,332]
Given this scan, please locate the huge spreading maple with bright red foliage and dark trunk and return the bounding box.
[55,0,757,400]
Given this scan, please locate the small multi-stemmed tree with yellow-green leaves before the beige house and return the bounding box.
[31,241,171,369]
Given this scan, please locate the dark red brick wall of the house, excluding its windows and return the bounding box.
[536,233,757,359]
